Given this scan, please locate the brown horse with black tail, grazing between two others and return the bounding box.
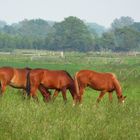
[26,69,76,101]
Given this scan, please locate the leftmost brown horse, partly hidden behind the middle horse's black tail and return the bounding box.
[0,67,50,101]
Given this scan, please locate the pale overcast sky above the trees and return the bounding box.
[0,0,140,27]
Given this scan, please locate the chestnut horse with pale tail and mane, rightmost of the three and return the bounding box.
[75,70,126,102]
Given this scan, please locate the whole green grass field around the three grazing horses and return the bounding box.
[0,53,140,140]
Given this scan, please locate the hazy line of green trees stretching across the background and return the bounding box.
[0,16,140,52]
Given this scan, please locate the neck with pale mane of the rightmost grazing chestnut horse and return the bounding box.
[113,74,122,96]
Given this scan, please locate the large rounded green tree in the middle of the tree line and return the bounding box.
[46,16,93,51]
